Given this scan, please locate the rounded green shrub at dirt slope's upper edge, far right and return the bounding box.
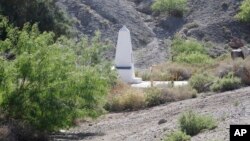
[211,73,242,92]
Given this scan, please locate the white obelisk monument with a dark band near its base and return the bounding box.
[115,26,142,84]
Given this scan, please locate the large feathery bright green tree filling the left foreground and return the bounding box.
[0,17,110,131]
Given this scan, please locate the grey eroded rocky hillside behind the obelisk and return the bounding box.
[58,0,250,68]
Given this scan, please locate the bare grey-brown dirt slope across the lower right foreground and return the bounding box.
[51,87,250,141]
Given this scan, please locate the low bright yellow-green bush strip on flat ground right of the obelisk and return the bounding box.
[176,53,213,65]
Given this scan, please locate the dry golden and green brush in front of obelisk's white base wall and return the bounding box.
[105,83,197,111]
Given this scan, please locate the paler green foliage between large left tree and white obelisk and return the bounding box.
[57,32,117,86]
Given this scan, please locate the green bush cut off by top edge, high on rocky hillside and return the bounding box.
[152,0,187,16]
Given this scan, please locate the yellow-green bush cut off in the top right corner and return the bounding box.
[236,0,250,22]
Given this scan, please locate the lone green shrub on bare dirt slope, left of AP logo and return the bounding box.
[179,111,217,136]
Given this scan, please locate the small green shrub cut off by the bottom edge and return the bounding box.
[164,131,191,141]
